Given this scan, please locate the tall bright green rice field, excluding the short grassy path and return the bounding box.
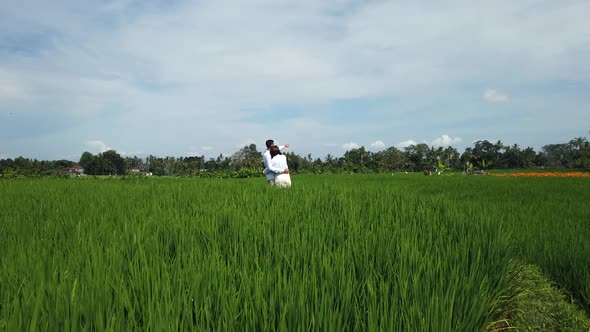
[0,174,590,331]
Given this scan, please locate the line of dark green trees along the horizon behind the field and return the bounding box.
[0,137,590,177]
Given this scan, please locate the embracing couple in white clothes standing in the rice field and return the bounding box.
[262,139,291,187]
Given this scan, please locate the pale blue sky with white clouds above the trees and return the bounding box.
[0,0,590,161]
